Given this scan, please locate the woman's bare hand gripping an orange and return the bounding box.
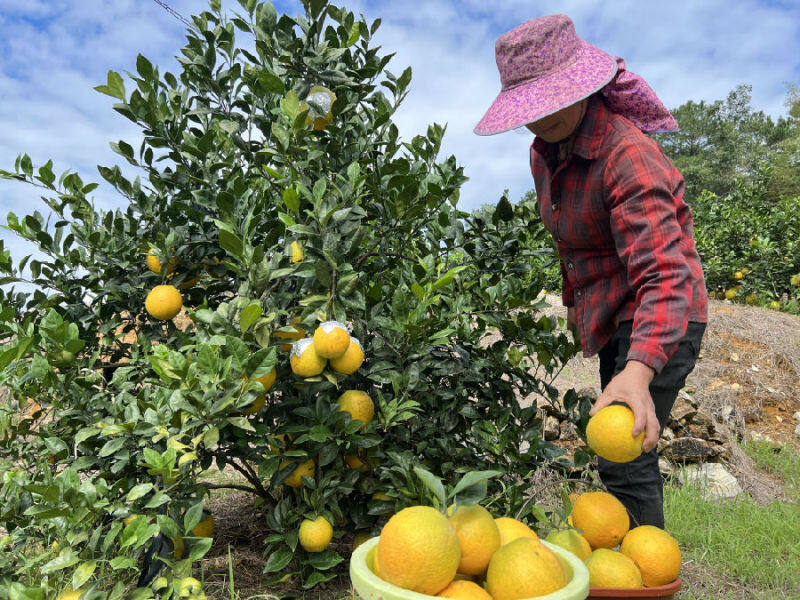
[589,360,661,452]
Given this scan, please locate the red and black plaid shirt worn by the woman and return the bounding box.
[531,95,708,372]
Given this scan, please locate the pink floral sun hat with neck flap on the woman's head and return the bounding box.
[474,15,678,135]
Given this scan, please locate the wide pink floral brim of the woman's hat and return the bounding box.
[473,40,617,135]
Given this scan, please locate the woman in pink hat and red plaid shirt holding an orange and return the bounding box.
[475,15,708,528]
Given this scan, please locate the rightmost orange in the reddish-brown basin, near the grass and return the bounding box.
[619,525,681,587]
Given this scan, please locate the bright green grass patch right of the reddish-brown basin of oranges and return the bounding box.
[664,486,800,598]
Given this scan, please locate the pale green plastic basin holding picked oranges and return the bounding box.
[350,537,589,600]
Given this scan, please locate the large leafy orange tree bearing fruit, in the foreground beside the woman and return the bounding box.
[0,0,587,599]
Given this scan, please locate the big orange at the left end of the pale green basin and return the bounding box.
[375,506,461,595]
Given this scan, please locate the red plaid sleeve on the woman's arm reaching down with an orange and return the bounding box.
[604,140,692,373]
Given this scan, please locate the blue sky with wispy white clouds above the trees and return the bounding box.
[0,0,800,268]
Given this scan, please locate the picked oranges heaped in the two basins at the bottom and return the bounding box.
[367,492,681,600]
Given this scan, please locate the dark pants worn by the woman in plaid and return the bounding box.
[597,321,706,529]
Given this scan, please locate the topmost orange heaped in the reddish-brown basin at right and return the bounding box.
[572,492,630,548]
